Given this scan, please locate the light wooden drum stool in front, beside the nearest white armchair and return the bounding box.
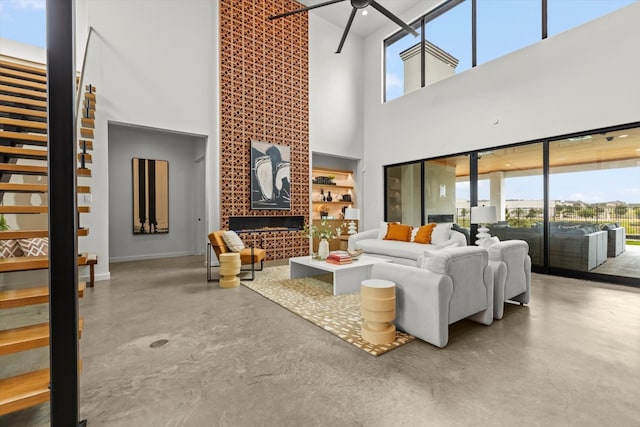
[360,279,396,344]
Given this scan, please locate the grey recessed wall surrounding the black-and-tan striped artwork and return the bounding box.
[109,124,204,262]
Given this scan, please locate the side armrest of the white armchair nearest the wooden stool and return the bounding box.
[371,263,453,347]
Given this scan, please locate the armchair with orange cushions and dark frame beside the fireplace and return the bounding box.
[207,230,267,282]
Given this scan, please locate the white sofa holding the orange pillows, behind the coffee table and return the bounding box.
[349,223,467,267]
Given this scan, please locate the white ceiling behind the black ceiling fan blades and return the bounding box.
[296,0,420,39]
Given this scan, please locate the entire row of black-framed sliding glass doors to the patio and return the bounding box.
[385,125,640,285]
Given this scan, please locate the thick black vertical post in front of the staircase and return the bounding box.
[46,0,79,427]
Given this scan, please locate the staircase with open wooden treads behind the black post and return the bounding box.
[0,58,96,416]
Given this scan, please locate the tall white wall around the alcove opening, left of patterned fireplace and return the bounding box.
[76,0,220,280]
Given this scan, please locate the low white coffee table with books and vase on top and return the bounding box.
[289,255,389,295]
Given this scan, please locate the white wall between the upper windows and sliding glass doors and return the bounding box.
[364,2,640,232]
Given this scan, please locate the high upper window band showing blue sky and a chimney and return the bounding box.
[384,0,638,101]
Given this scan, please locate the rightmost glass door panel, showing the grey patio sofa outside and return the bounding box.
[549,129,640,277]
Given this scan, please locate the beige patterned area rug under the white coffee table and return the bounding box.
[242,266,415,356]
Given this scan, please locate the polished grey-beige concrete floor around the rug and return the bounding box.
[0,257,640,427]
